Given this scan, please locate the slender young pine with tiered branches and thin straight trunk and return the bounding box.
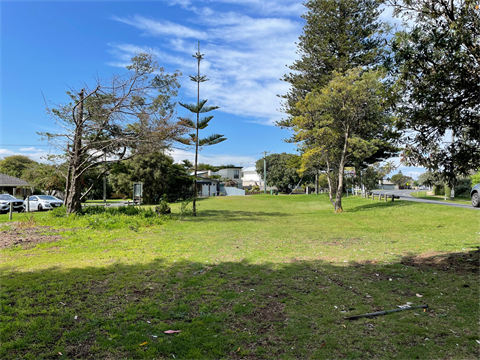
[179,42,227,216]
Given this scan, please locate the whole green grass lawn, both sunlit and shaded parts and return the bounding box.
[0,195,480,359]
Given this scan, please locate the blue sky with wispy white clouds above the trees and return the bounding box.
[0,0,422,177]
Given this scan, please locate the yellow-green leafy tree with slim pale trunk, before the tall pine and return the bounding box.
[292,68,395,212]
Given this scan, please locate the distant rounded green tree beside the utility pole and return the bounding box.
[255,153,300,192]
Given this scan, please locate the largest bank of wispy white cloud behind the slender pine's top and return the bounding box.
[110,1,302,125]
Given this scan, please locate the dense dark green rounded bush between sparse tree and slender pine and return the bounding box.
[109,152,191,203]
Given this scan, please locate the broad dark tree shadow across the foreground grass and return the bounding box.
[0,252,480,359]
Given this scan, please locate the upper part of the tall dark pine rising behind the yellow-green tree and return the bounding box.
[277,0,385,128]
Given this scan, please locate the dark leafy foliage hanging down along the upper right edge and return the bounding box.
[390,0,480,185]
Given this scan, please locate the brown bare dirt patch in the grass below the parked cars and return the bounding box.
[0,223,61,249]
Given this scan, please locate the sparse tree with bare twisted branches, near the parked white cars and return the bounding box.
[39,54,184,213]
